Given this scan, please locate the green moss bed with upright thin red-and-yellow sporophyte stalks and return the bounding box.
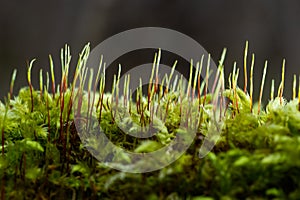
[0,43,300,199]
